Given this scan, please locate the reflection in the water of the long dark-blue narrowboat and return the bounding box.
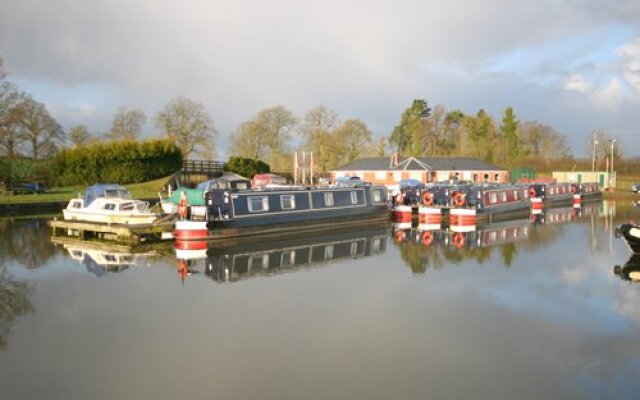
[175,223,389,282]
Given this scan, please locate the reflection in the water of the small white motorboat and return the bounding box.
[52,239,158,277]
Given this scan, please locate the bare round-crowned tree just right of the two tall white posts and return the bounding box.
[301,106,340,172]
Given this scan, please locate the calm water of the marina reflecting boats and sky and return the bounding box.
[0,203,640,399]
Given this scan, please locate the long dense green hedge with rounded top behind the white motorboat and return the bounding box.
[51,140,182,186]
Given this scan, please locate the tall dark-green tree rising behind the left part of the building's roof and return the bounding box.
[389,99,431,156]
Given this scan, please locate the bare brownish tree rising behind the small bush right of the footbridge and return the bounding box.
[231,106,297,170]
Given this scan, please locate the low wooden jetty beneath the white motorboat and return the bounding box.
[49,219,174,244]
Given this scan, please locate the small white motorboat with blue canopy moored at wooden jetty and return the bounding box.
[62,184,158,225]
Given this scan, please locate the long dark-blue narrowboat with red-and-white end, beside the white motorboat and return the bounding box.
[174,185,389,240]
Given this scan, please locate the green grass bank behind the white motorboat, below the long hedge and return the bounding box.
[0,177,169,204]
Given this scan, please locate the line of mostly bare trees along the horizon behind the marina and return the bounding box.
[0,54,622,179]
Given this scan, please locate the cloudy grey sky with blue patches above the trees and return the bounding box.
[0,0,640,156]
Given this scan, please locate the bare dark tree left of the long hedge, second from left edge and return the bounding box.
[20,99,65,161]
